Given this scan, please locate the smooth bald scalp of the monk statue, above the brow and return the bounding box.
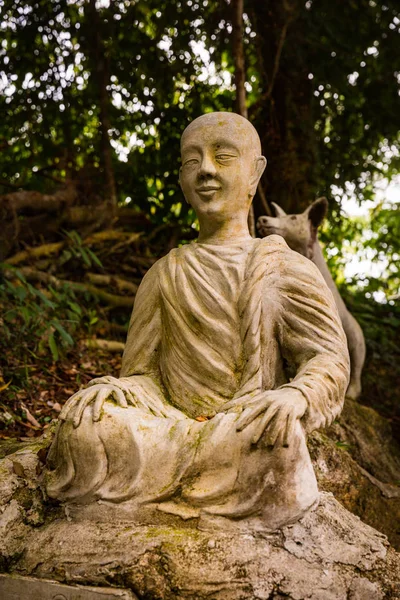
[181,112,261,158]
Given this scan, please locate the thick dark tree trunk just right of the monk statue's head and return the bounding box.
[249,0,318,216]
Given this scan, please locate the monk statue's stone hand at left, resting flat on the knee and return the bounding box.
[59,383,135,427]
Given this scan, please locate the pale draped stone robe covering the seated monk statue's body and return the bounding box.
[47,235,349,527]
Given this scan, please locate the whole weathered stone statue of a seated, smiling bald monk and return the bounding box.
[47,112,349,529]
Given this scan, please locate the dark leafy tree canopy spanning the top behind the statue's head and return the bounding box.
[0,0,400,288]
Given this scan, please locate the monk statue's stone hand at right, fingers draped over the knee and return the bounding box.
[221,388,307,447]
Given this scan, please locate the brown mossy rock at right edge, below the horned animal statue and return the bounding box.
[308,400,400,550]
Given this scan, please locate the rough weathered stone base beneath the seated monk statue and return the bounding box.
[0,438,400,600]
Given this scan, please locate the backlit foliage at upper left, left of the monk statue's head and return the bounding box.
[0,0,232,222]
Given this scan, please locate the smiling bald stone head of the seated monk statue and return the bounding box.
[179,112,267,221]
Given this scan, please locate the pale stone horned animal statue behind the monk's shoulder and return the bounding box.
[257,198,365,400]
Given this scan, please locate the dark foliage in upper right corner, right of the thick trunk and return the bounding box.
[306,0,400,200]
